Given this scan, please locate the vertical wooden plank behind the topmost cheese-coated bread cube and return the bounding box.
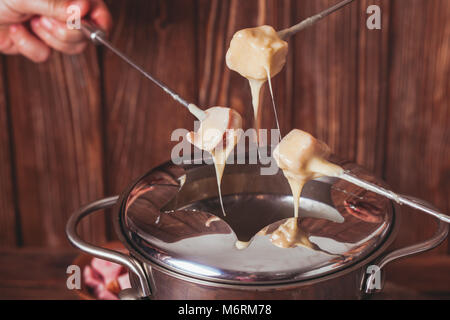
[197,0,293,134]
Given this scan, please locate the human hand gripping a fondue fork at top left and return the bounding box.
[0,0,112,62]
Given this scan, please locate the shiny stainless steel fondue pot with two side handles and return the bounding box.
[66,154,448,299]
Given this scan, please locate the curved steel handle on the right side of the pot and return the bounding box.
[362,197,449,294]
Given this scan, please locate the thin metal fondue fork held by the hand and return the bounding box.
[81,21,206,121]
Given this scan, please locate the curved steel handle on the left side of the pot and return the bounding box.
[66,196,151,298]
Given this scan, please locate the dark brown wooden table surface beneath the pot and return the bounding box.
[0,248,450,300]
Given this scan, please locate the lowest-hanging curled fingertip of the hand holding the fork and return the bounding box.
[9,25,50,62]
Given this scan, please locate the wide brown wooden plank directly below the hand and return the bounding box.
[7,48,104,246]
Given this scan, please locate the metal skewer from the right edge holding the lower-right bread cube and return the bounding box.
[339,172,450,223]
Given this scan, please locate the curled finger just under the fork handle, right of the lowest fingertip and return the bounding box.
[31,18,87,54]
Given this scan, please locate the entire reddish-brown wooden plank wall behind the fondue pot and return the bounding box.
[0,0,450,260]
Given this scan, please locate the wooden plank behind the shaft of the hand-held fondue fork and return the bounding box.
[103,0,197,194]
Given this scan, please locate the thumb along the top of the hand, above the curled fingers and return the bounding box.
[13,0,90,21]
